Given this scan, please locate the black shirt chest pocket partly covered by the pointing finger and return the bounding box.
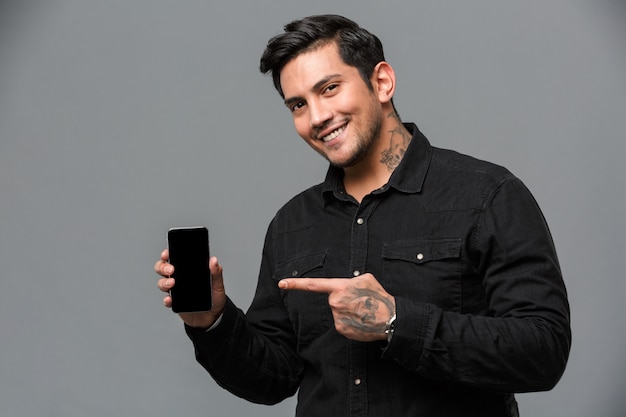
[274,250,334,349]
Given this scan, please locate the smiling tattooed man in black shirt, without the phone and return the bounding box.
[155,15,570,417]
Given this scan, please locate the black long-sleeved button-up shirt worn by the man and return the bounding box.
[187,124,571,417]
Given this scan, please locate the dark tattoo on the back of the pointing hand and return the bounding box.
[342,288,394,333]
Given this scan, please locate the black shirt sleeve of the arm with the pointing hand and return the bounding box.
[383,178,571,392]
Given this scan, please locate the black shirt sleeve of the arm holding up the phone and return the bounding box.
[186,223,303,404]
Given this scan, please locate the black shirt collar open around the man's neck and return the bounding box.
[322,123,432,203]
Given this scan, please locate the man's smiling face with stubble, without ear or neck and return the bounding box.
[280,42,383,168]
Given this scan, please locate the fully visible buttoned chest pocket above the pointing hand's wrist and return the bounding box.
[383,238,462,311]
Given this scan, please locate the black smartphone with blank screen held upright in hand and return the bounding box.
[167,226,212,313]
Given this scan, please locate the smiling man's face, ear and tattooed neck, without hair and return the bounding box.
[280,40,402,201]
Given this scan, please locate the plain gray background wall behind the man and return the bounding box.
[0,0,626,417]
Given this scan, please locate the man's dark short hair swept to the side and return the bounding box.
[259,14,385,97]
